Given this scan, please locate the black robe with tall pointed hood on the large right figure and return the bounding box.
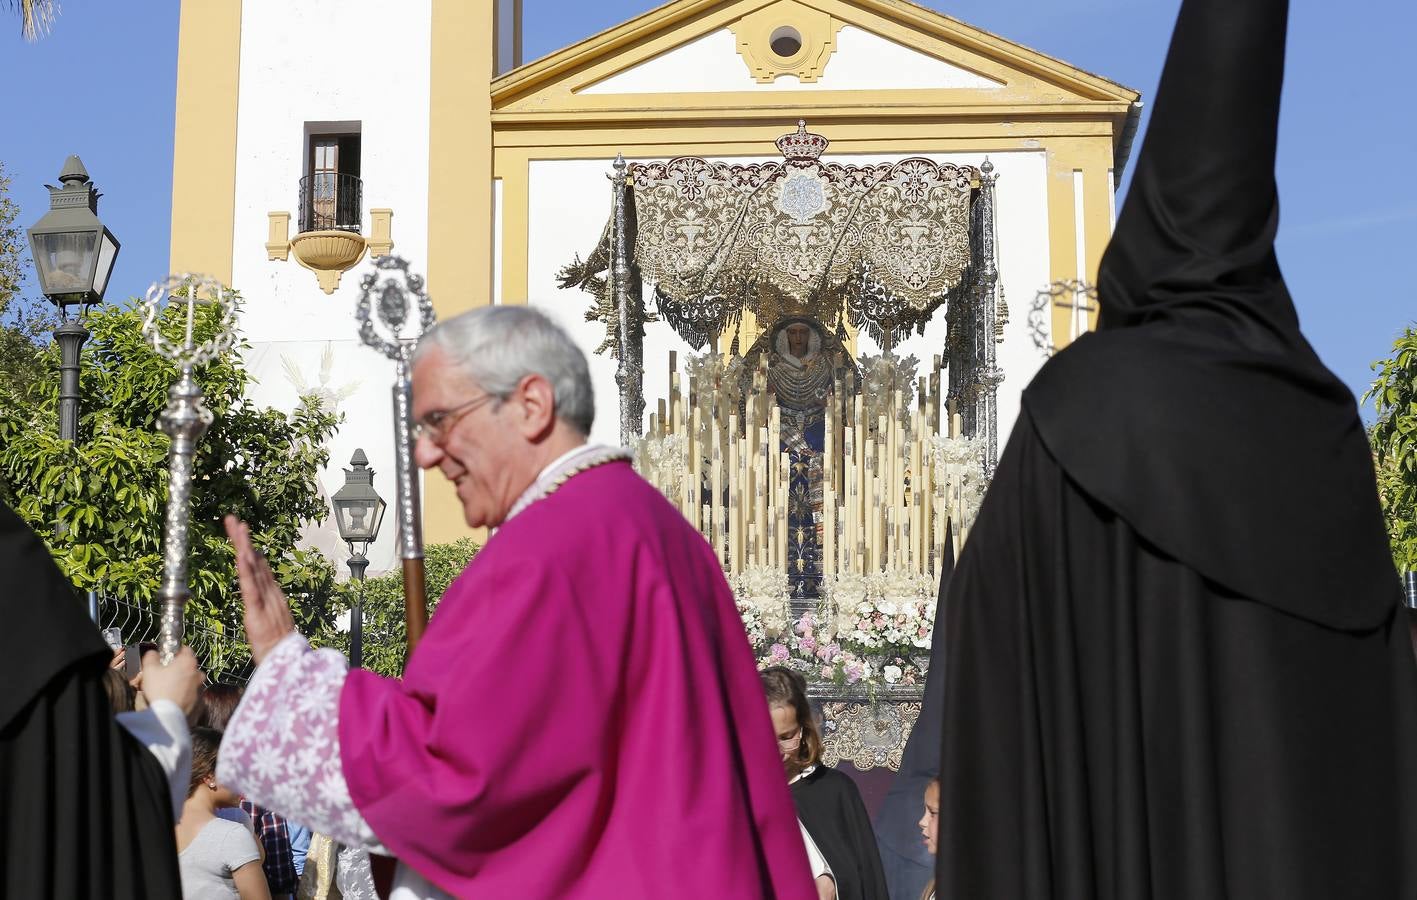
[937,0,1417,900]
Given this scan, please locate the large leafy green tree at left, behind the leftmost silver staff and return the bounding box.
[0,291,339,680]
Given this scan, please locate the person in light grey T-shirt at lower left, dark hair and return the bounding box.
[177,727,271,900]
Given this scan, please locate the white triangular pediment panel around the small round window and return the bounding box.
[580,26,1003,94]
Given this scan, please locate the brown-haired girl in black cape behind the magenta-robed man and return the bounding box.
[762,666,888,900]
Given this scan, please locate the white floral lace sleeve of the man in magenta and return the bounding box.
[217,634,385,853]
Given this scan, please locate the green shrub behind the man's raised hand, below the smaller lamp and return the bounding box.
[312,537,478,676]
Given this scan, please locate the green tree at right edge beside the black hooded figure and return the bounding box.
[1363,326,1417,571]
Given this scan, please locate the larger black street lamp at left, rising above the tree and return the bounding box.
[30,156,119,441]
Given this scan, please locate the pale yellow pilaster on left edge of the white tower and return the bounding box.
[169,0,241,285]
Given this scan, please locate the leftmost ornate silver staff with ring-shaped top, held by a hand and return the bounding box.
[143,275,237,665]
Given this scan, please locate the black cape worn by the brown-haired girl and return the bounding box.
[792,765,888,900]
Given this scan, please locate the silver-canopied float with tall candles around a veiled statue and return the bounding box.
[561,122,1007,764]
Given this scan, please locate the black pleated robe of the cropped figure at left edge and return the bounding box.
[0,505,181,900]
